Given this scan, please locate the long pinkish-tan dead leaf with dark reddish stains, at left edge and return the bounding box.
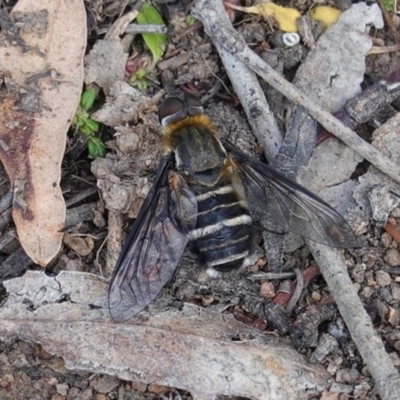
[0,0,86,266]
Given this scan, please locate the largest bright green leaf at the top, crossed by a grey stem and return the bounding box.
[136,3,167,68]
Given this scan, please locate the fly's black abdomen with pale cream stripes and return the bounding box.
[190,179,253,272]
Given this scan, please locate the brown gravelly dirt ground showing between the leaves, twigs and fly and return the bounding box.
[0,0,400,400]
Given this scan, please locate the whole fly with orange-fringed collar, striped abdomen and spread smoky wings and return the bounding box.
[109,94,358,322]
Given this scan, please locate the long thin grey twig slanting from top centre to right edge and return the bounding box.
[193,0,400,187]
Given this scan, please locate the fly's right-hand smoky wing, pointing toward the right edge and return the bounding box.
[222,140,360,247]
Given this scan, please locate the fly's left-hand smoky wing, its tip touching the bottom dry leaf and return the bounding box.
[108,154,197,322]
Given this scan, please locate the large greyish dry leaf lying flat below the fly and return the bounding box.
[0,271,329,400]
